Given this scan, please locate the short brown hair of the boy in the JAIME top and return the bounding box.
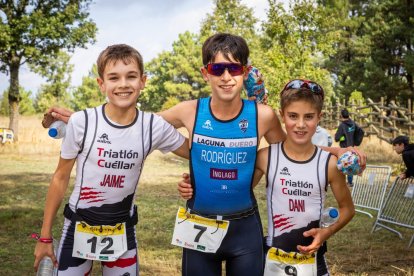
[96,44,144,79]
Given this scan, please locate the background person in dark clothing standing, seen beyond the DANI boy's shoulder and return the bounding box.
[335,109,356,187]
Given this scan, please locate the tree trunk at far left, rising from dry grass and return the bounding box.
[9,57,20,141]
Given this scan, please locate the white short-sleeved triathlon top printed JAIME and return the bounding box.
[61,105,185,222]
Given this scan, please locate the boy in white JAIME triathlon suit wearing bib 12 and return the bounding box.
[34,44,188,276]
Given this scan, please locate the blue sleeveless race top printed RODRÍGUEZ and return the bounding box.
[188,98,258,215]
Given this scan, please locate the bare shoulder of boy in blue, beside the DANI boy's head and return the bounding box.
[257,104,286,144]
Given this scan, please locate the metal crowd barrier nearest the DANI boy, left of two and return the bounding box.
[352,165,391,218]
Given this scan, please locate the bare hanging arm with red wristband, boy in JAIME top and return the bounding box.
[34,158,76,271]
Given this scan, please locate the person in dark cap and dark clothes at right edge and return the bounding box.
[392,135,414,179]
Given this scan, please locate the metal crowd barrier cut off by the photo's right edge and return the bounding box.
[371,178,414,247]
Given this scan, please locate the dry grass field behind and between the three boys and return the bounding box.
[0,117,414,275]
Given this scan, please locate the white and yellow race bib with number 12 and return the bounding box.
[72,221,128,262]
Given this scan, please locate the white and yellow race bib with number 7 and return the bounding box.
[171,207,230,253]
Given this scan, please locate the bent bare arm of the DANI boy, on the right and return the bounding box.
[297,156,355,254]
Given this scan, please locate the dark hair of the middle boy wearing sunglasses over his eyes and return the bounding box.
[202,33,250,65]
